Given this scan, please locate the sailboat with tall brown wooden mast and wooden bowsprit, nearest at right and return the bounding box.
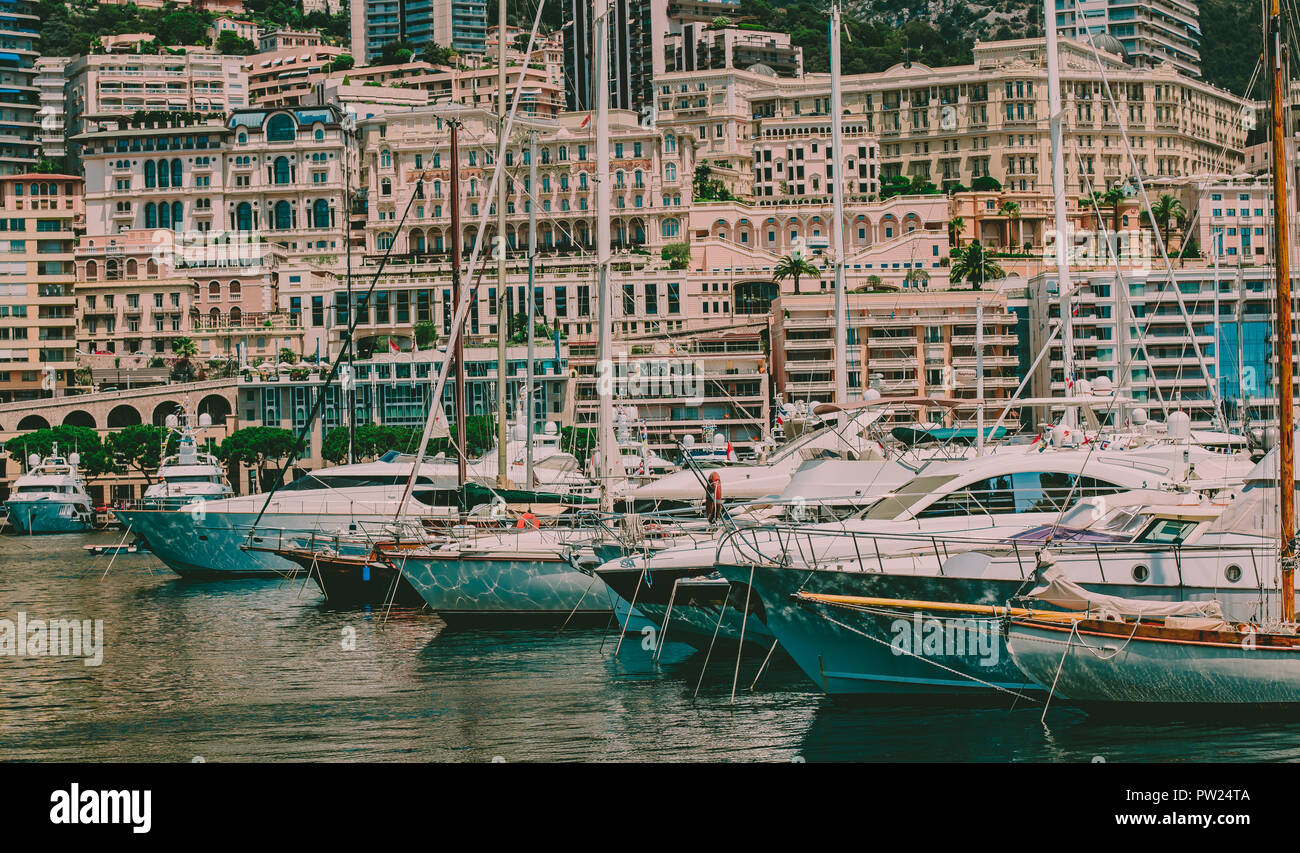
[1006,0,1300,711]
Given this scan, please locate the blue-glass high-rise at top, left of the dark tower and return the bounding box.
[351,0,488,65]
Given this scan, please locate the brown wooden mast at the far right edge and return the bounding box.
[1269,0,1296,624]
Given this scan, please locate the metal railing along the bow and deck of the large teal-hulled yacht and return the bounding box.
[715,523,1277,585]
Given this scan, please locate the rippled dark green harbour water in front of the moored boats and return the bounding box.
[0,533,1300,762]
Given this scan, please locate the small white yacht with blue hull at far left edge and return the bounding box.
[5,445,95,533]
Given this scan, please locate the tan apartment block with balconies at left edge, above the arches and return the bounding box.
[0,173,86,402]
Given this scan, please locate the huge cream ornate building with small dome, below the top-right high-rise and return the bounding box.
[657,39,1253,204]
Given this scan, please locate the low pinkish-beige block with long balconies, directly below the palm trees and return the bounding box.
[772,289,1022,424]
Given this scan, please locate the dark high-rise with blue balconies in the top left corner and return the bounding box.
[0,0,40,174]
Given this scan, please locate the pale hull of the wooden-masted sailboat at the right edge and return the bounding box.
[1006,620,1300,709]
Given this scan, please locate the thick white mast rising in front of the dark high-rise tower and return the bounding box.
[592,0,618,512]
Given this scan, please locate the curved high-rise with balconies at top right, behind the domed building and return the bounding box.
[1057,0,1201,77]
